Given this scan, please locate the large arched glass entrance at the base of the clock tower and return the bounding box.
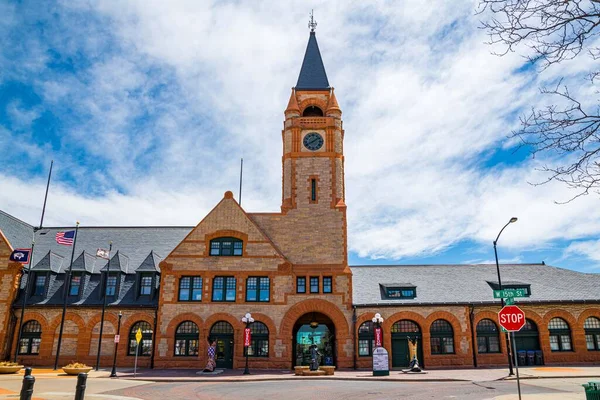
[292,312,336,366]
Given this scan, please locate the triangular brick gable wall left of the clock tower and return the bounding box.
[167,191,284,259]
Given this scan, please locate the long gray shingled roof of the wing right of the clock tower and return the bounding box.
[350,264,600,305]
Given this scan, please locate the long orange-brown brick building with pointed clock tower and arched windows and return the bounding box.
[0,32,600,369]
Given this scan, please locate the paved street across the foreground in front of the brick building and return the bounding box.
[105,379,587,400]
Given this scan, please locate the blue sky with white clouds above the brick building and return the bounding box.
[0,1,600,272]
